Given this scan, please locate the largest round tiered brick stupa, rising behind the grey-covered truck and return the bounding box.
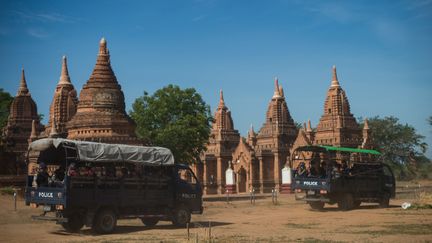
[67,38,142,145]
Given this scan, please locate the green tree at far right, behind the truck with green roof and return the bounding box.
[362,116,427,179]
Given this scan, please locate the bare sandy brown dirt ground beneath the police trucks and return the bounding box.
[0,192,432,242]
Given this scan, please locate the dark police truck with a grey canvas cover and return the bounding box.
[25,138,203,233]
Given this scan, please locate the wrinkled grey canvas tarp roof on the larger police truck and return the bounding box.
[29,138,174,165]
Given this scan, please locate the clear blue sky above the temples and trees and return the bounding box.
[0,0,432,157]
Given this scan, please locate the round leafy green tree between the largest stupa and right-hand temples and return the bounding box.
[129,85,213,163]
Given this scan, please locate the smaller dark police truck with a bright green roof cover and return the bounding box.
[291,145,395,210]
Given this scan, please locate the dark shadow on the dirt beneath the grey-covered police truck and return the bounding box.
[50,221,232,236]
